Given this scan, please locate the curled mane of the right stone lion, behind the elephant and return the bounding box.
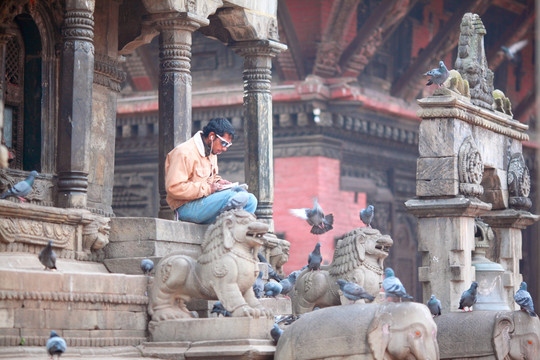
[328,228,366,277]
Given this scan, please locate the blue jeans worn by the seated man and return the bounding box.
[175,189,257,224]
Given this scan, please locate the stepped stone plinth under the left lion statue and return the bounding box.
[143,317,275,360]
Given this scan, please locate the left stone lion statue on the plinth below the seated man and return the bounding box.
[149,210,273,324]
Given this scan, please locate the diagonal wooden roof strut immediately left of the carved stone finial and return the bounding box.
[391,0,492,101]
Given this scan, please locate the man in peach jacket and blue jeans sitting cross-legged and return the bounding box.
[165,118,257,224]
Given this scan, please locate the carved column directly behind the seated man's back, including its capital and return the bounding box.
[155,13,208,219]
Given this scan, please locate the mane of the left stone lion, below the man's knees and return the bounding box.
[197,209,256,264]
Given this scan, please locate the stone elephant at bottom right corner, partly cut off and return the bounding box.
[435,311,540,360]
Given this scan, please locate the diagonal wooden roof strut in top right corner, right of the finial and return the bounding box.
[487,1,536,71]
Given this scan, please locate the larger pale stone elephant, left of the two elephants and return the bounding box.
[274,302,439,360]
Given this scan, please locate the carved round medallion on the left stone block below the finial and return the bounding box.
[458,136,484,196]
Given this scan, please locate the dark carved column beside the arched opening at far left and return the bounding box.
[57,0,95,208]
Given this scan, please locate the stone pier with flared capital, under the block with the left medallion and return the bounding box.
[405,197,491,311]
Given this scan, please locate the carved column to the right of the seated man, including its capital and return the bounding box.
[233,40,287,231]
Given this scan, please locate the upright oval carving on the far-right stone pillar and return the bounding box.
[507,153,532,210]
